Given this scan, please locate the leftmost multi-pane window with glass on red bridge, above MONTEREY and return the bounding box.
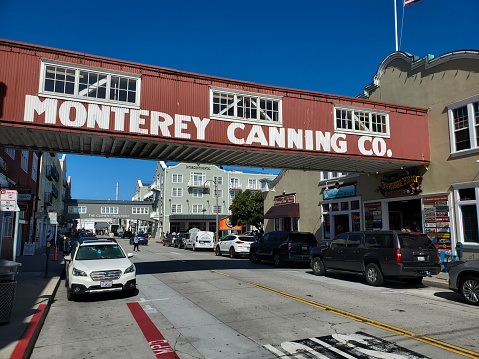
[40,61,140,106]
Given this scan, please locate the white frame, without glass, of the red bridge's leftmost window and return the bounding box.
[38,59,141,109]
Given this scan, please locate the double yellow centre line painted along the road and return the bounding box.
[249,283,479,359]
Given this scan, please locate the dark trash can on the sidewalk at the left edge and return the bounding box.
[0,259,22,323]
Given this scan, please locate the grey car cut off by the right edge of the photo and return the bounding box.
[449,259,479,305]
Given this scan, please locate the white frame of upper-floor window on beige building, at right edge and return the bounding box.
[447,95,479,157]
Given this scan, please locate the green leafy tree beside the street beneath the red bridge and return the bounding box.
[230,189,264,234]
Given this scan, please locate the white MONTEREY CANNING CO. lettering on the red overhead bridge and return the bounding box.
[23,95,392,157]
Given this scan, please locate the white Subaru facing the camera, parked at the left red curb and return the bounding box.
[64,240,136,300]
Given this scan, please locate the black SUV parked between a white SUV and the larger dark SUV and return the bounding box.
[249,231,318,267]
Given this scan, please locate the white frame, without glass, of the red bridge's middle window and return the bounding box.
[210,87,283,127]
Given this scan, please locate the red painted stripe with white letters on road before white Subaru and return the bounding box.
[126,302,180,359]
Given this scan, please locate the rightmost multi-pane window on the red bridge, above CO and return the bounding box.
[334,106,389,136]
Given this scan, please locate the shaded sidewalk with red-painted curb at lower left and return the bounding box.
[0,248,64,359]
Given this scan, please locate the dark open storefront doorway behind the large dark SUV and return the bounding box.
[388,199,423,232]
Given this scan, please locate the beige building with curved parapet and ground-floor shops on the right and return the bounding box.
[265,51,479,259]
